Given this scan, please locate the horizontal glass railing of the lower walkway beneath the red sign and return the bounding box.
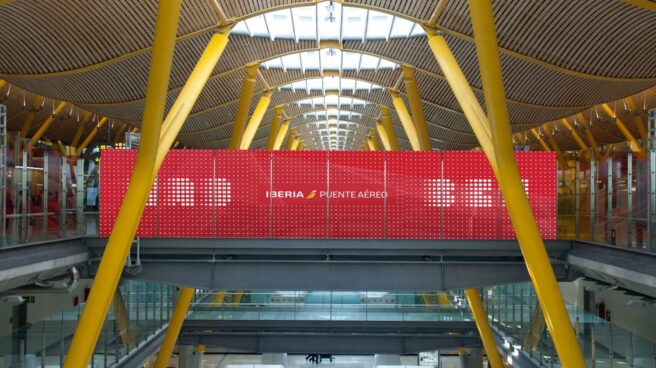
[188,291,472,321]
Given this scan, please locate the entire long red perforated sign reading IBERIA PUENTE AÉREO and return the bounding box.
[100,150,556,239]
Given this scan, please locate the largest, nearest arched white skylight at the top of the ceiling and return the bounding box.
[232,1,424,42]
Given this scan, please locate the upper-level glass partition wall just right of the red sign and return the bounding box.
[558,142,656,252]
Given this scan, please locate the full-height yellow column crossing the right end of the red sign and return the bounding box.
[469,0,585,368]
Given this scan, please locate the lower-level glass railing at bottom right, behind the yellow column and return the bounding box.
[482,283,656,368]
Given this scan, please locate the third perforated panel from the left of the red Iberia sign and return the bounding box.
[214,150,271,238]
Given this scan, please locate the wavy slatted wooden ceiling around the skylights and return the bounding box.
[0,0,656,149]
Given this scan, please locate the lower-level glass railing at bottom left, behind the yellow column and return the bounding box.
[0,281,176,367]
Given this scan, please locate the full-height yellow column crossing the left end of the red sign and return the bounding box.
[64,0,182,368]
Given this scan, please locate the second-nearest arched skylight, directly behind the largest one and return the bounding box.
[262,48,399,73]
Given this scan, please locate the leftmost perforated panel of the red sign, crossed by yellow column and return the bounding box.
[100,149,157,237]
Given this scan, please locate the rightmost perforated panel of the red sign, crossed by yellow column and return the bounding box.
[501,152,557,239]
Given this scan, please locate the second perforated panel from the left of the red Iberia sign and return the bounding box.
[157,150,214,238]
